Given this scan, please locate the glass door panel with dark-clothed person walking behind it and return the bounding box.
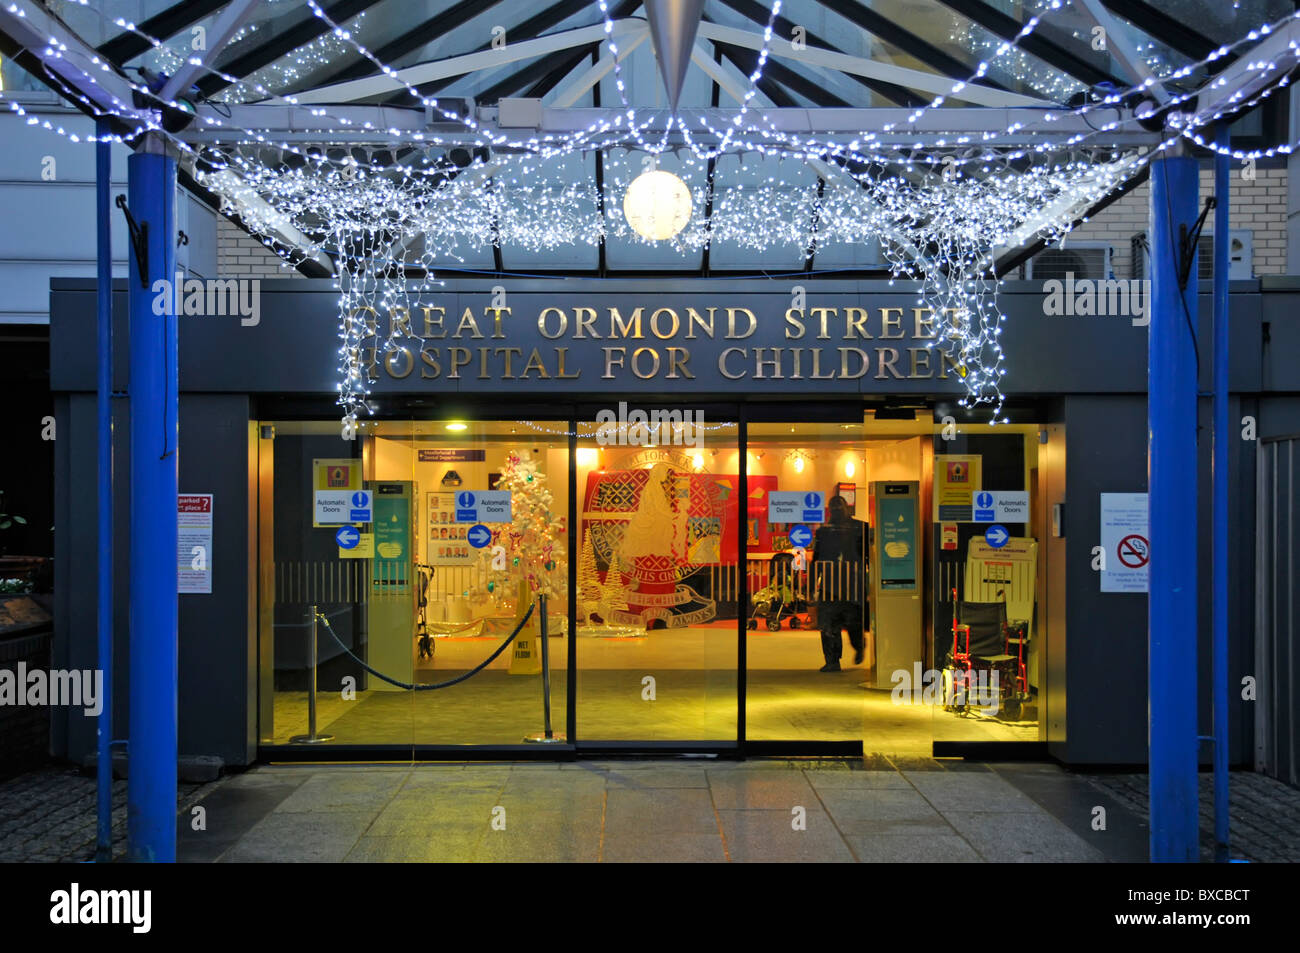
[745,423,872,742]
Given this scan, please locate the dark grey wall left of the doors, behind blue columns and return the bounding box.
[55,394,256,764]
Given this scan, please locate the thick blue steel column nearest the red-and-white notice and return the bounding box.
[126,137,177,862]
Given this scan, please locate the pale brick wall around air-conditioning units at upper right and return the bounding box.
[1065,166,1287,278]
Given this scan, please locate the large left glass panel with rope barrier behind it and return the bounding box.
[260,420,568,746]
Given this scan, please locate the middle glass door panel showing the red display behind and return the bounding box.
[575,410,744,742]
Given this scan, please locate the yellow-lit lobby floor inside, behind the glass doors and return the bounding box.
[264,627,1039,758]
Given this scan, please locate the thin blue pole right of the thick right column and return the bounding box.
[1213,122,1234,863]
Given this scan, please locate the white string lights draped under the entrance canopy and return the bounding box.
[8,0,1300,423]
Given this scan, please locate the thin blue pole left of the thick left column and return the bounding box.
[95,120,113,862]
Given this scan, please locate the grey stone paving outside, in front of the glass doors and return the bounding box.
[179,759,1128,863]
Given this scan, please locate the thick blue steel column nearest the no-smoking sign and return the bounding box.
[1147,146,1200,862]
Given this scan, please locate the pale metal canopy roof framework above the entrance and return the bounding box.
[0,0,1296,273]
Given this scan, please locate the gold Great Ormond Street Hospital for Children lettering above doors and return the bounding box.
[356,298,966,386]
